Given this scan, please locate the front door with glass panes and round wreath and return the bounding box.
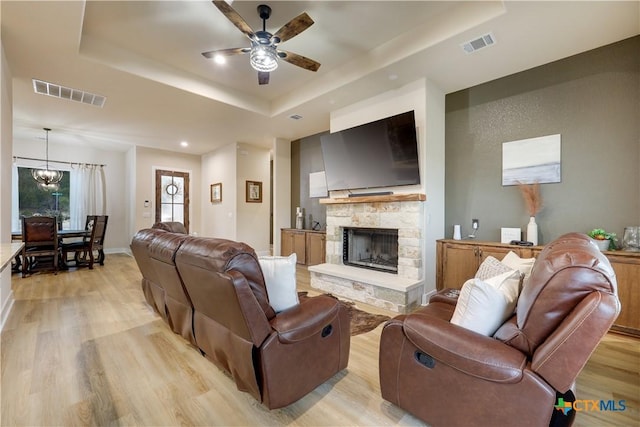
[155,169,189,233]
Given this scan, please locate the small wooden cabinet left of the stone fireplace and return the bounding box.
[280,228,326,265]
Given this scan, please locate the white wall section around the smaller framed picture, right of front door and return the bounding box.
[200,144,239,240]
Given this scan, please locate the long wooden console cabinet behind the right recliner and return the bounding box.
[436,239,640,336]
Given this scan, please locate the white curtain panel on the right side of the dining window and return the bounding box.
[69,165,107,230]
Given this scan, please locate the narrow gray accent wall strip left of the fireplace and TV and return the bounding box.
[291,131,329,230]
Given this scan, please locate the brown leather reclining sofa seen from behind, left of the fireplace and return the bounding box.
[131,229,350,409]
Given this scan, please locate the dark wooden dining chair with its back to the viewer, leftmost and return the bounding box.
[22,216,61,277]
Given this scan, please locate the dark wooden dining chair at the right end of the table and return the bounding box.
[62,215,109,269]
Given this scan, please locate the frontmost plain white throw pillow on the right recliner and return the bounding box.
[451,270,520,336]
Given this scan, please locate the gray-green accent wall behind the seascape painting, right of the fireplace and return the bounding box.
[444,36,640,244]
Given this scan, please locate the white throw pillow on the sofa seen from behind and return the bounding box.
[258,253,300,313]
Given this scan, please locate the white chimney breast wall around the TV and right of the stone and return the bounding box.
[330,79,445,293]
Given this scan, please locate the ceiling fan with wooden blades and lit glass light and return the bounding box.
[202,0,320,85]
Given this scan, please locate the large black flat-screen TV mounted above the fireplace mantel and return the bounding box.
[320,111,420,191]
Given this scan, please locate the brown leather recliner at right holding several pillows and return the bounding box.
[379,233,620,427]
